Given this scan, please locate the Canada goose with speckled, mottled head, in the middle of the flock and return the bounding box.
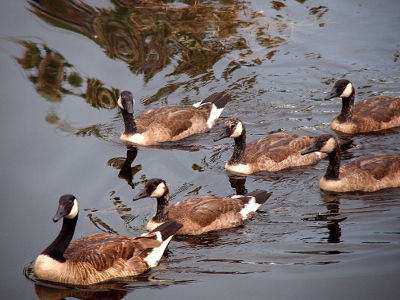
[214,117,326,174]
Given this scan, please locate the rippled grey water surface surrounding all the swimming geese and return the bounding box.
[0,0,400,299]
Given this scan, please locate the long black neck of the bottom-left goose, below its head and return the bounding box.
[42,216,78,262]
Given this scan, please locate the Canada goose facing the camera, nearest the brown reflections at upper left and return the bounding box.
[118,91,231,146]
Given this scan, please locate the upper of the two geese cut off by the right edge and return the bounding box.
[325,79,400,134]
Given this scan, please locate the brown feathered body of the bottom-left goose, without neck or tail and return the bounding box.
[34,233,161,285]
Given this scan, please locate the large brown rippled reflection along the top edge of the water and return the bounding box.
[28,0,285,81]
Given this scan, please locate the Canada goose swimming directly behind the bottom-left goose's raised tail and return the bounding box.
[133,178,271,235]
